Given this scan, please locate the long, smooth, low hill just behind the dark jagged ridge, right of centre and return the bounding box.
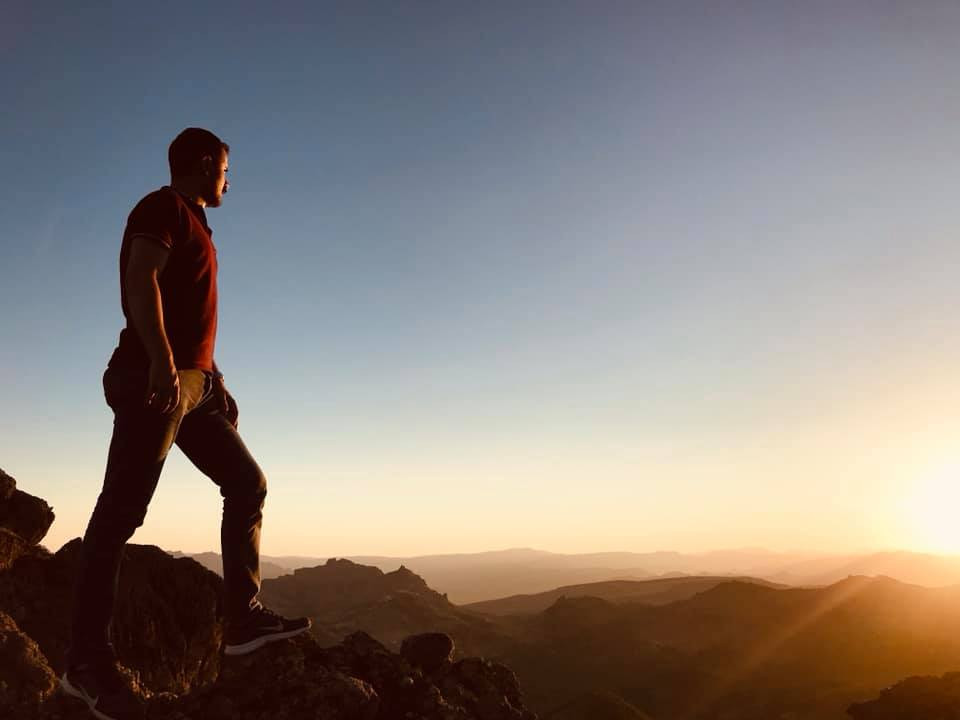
[462,576,786,615]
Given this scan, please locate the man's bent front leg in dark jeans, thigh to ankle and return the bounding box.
[176,395,267,623]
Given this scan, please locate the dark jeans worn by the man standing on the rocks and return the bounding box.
[70,369,267,662]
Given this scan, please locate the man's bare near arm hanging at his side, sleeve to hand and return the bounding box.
[123,236,180,413]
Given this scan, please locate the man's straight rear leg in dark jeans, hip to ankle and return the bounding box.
[69,370,209,663]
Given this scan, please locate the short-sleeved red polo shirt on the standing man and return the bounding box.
[110,185,217,372]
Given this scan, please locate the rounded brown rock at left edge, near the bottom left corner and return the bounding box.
[0,612,57,720]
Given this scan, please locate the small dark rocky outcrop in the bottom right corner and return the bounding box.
[847,672,960,720]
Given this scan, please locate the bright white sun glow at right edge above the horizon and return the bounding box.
[904,462,960,553]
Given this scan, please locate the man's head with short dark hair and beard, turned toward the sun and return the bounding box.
[167,128,230,207]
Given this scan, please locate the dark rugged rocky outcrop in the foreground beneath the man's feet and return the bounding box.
[0,476,536,720]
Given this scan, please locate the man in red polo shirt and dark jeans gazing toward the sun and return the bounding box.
[61,128,310,720]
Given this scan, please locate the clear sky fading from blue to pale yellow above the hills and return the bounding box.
[0,0,960,557]
